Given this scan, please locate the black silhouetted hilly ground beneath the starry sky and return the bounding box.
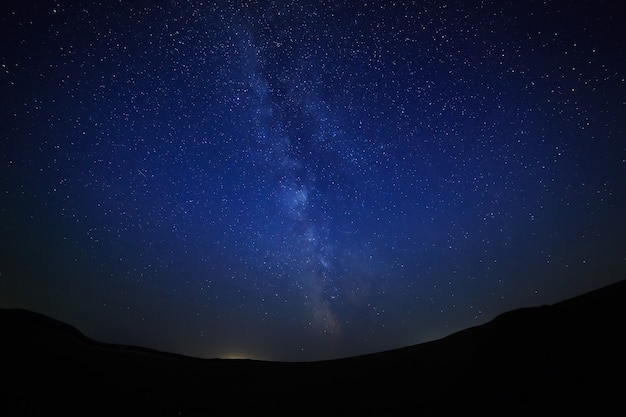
[0,281,626,417]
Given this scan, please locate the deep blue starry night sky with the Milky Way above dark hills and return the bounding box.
[0,0,626,361]
